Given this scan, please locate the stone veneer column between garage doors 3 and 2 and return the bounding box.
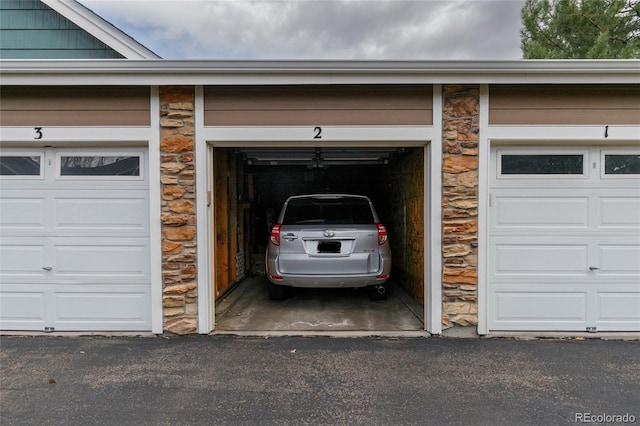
[160,86,198,334]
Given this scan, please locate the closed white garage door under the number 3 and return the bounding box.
[0,148,151,331]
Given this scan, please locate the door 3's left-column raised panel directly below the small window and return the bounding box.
[0,196,46,232]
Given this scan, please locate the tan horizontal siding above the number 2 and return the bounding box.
[204,85,433,126]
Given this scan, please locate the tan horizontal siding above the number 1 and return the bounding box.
[489,85,640,125]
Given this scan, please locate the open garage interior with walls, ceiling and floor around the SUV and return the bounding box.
[212,145,425,332]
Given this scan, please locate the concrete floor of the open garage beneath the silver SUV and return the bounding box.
[215,275,427,336]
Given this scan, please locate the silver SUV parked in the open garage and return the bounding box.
[266,194,391,300]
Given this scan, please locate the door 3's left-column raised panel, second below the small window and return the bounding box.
[0,243,46,281]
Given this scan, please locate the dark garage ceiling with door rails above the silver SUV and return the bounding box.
[237,147,404,168]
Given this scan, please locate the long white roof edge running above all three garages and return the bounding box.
[0,59,640,85]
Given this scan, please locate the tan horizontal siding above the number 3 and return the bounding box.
[0,86,150,126]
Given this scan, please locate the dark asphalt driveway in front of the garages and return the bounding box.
[0,335,640,425]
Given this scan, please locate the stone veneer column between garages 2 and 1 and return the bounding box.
[442,85,480,326]
